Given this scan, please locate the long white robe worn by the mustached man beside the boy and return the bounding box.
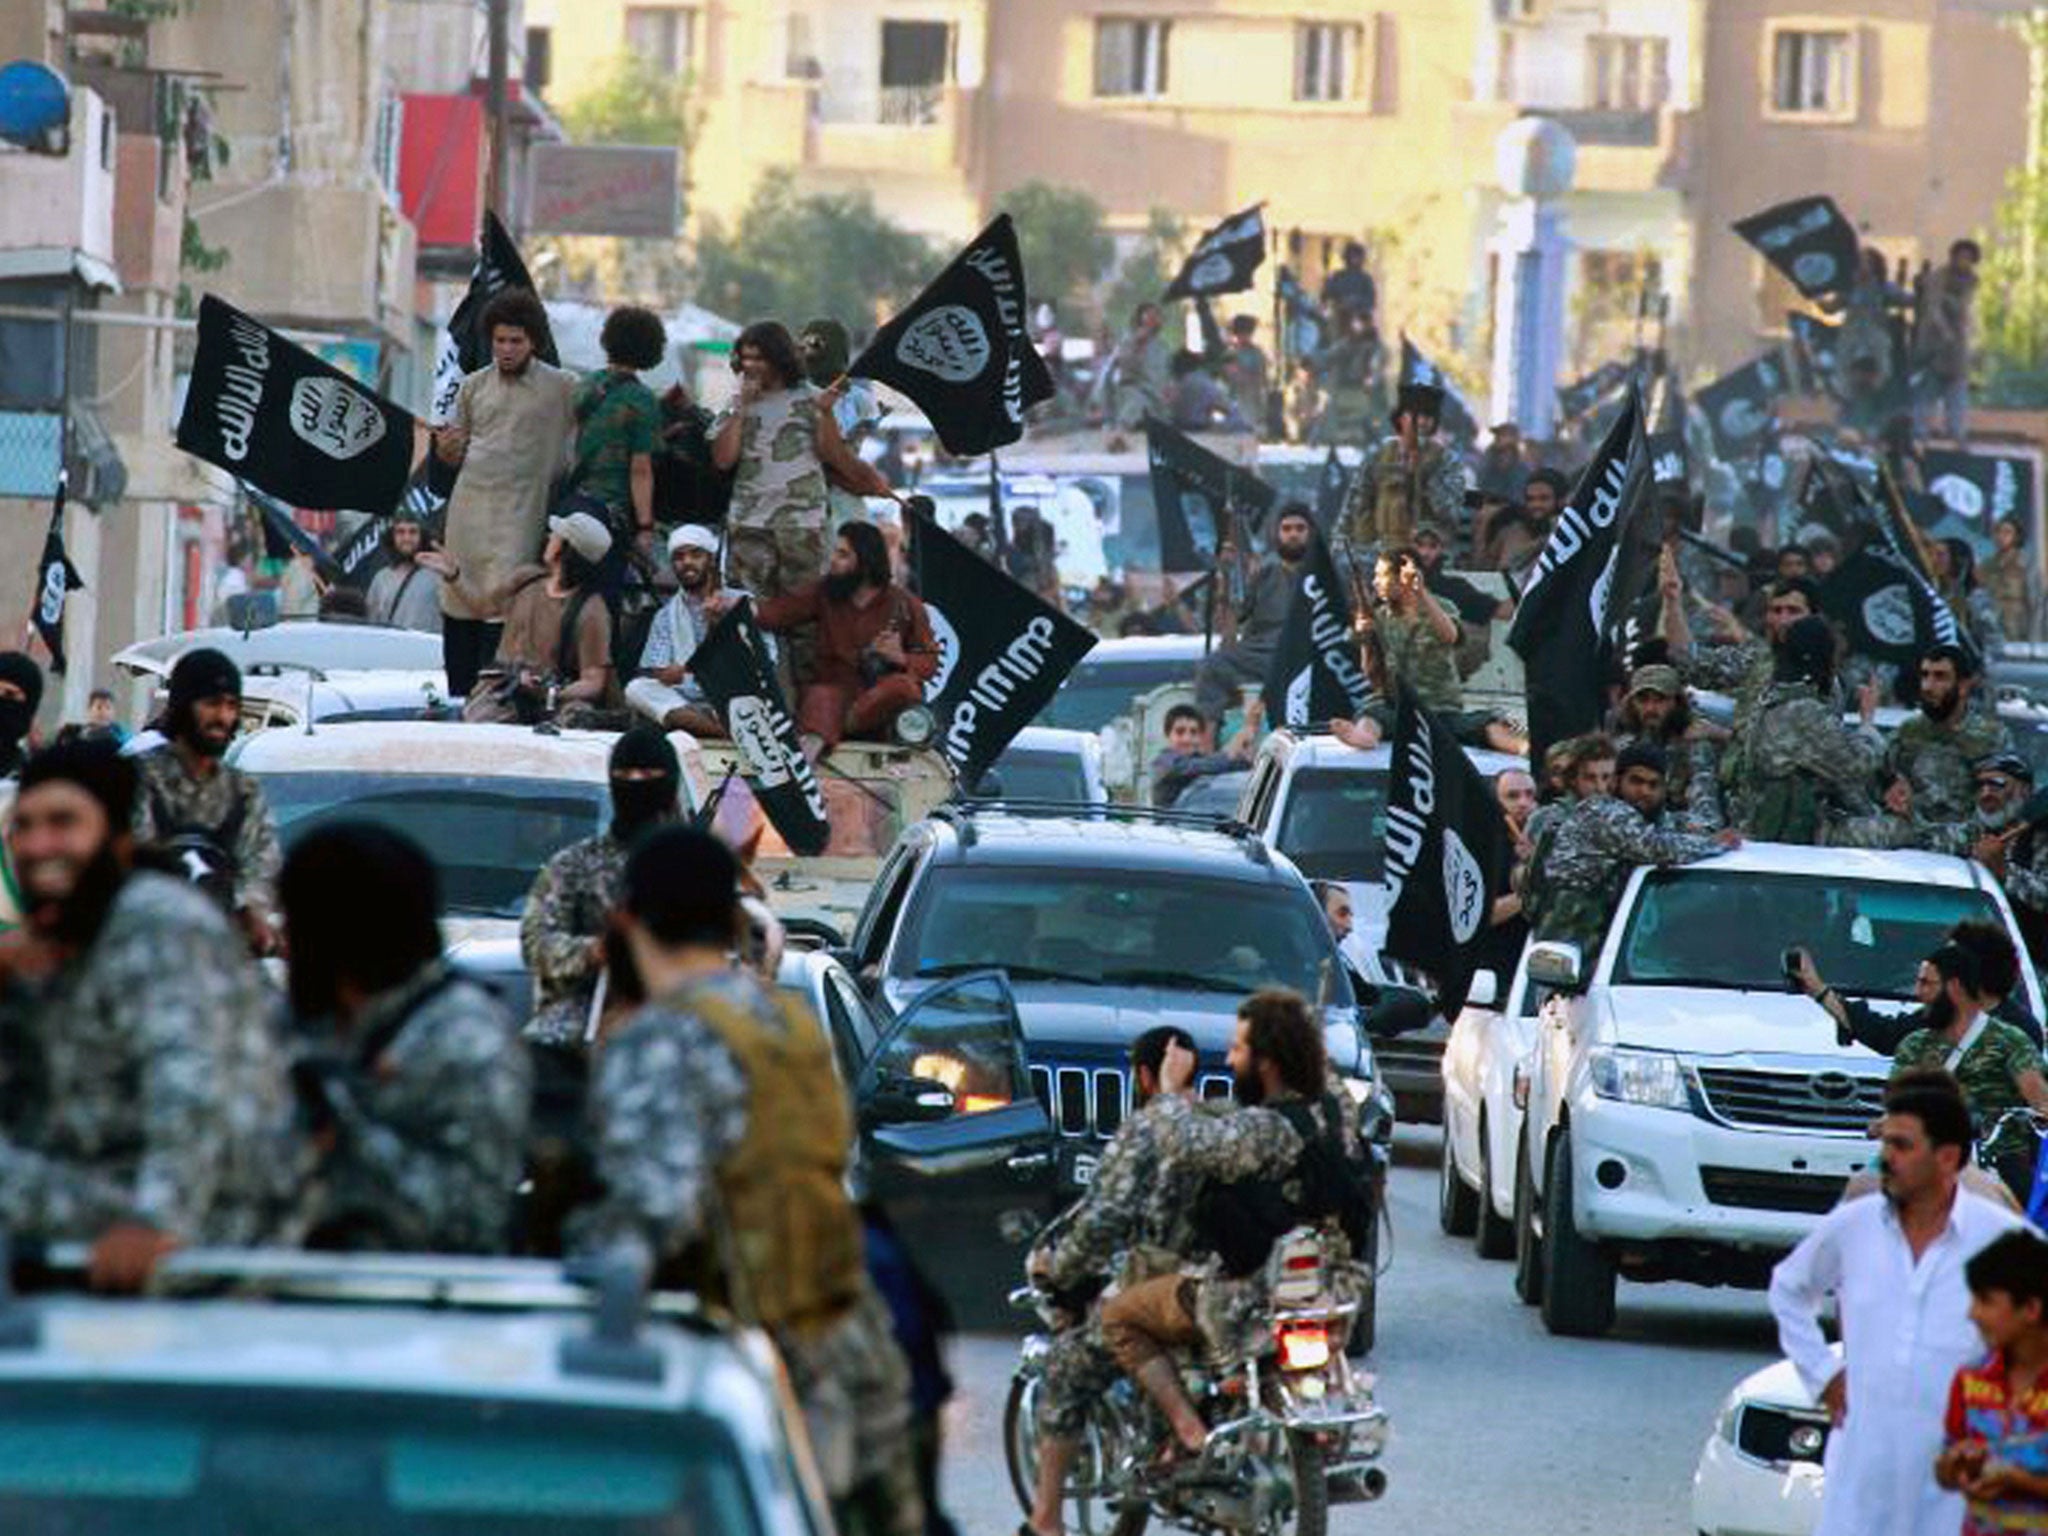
[1772,1190,2025,1536]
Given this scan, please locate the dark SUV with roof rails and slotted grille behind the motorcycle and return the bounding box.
[844,801,1393,1196]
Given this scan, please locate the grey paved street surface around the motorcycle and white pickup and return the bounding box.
[946,1126,1776,1536]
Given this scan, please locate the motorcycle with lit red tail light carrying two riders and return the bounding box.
[1004,1227,1386,1536]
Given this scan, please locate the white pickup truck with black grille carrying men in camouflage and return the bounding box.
[1516,844,2044,1335]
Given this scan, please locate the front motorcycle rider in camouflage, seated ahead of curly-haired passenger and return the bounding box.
[1018,1024,1202,1536]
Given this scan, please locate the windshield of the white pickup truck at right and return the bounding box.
[1614,866,2003,1001]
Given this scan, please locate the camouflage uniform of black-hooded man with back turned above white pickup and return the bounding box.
[1731,682,1884,844]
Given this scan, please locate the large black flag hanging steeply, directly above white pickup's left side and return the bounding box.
[1507,389,1651,762]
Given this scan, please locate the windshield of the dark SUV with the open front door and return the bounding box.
[891,868,1352,1004]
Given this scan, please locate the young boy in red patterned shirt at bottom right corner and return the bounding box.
[1933,1229,2048,1536]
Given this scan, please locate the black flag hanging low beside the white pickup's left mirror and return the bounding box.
[1382,688,1513,1018]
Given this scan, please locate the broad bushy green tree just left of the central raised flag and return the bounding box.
[694,170,938,332]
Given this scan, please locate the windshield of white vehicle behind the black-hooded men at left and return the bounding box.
[256,772,610,918]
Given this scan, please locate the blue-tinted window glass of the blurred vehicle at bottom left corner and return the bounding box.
[0,1386,764,1536]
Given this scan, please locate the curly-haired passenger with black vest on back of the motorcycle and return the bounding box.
[1102,987,1370,1454]
